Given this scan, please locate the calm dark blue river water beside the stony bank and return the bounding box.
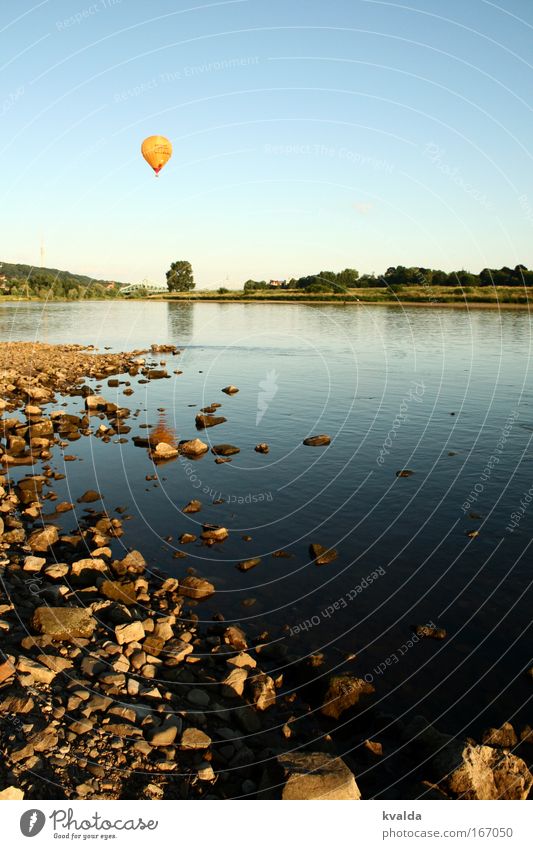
[0,301,533,733]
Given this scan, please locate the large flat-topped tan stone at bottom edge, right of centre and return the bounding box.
[277,752,361,801]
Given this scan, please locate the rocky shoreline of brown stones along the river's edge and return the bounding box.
[0,343,533,800]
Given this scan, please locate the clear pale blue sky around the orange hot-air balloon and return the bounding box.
[0,0,533,287]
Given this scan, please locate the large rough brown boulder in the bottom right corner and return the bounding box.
[432,741,533,800]
